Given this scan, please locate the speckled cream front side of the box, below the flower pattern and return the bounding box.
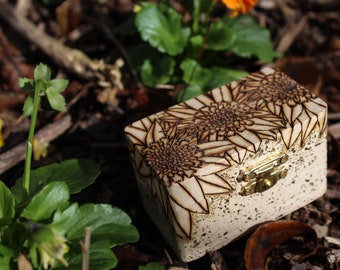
[175,135,327,261]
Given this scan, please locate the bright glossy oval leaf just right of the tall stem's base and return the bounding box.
[21,181,70,221]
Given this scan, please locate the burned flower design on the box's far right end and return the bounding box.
[235,68,327,149]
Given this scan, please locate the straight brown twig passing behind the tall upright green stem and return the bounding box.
[0,115,72,174]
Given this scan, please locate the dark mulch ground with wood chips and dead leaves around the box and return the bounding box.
[0,0,340,270]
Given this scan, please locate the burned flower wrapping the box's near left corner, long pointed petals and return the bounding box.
[125,117,233,238]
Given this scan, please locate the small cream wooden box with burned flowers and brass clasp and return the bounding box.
[125,68,327,262]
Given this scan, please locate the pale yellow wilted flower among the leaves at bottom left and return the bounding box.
[37,236,69,269]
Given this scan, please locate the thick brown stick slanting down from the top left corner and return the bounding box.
[0,1,123,89]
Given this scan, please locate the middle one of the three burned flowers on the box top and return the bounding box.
[160,85,284,163]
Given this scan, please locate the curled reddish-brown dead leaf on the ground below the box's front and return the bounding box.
[244,220,317,270]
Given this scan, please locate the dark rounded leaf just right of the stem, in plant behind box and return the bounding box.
[206,22,236,50]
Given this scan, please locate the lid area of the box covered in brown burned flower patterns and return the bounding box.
[125,68,327,238]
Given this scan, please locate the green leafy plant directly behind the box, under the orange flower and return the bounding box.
[131,0,276,101]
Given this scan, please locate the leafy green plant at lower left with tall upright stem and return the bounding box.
[0,64,139,270]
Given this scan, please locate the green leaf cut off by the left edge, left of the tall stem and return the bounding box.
[0,181,15,227]
